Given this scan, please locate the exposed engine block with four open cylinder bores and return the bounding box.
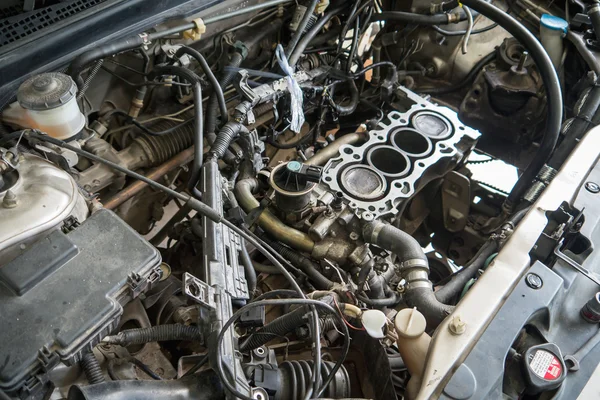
[323,89,480,218]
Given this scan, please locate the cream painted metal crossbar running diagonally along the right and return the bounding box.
[417,127,600,400]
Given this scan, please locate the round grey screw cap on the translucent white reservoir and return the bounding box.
[17,72,77,110]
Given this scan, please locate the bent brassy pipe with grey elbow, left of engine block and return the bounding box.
[235,178,315,253]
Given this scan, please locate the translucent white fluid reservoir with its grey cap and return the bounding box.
[2,72,85,140]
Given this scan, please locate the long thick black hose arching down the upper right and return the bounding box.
[462,0,563,205]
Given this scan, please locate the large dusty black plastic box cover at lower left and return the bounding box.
[0,210,161,394]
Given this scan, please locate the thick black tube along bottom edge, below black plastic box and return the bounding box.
[67,371,225,400]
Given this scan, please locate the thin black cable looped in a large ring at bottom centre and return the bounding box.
[215,299,350,400]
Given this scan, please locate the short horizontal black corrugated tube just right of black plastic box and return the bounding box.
[106,324,203,347]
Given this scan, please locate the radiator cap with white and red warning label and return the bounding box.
[523,343,567,394]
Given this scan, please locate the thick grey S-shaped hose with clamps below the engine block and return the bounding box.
[363,221,454,329]
